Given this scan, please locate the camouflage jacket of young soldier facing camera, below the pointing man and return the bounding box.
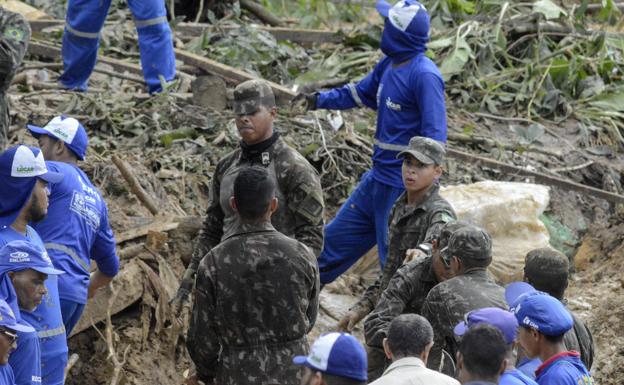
[353,185,457,313]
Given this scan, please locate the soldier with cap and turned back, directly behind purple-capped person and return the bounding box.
[422,226,507,375]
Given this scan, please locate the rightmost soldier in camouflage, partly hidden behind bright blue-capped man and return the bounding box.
[524,248,594,370]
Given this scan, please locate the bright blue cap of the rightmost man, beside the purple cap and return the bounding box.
[505,282,574,336]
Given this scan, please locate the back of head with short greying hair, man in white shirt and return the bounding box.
[388,314,433,358]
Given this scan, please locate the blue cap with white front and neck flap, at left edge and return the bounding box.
[0,145,63,228]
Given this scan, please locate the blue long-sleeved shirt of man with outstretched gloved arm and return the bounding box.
[316,54,447,188]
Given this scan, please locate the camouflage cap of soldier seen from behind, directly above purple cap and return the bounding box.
[440,225,492,261]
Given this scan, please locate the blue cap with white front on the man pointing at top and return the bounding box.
[375,0,429,37]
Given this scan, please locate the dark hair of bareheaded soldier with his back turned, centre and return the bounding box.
[234,166,275,220]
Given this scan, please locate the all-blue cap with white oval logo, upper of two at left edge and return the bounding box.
[0,241,65,275]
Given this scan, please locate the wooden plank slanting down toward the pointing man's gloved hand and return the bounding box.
[175,49,297,101]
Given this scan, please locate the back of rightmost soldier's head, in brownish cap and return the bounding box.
[524,248,570,299]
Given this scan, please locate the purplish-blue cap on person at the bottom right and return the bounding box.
[455,307,518,345]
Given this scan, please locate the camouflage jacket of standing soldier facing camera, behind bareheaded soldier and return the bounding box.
[176,138,325,292]
